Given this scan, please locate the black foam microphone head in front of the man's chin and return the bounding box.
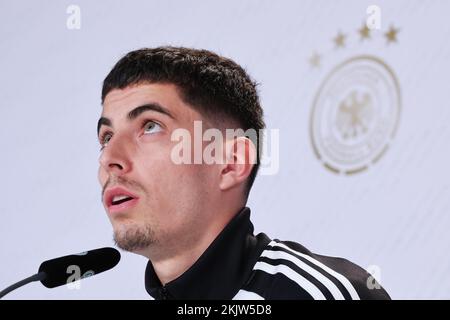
[39,248,120,288]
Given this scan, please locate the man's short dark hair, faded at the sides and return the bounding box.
[102,46,265,196]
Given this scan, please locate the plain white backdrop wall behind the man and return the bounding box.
[0,0,450,299]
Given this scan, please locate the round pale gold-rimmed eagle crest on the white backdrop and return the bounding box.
[310,56,401,174]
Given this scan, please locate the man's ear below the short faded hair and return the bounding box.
[219,137,257,191]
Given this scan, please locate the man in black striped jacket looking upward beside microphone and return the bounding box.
[98,47,389,299]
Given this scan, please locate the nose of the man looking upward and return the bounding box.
[99,134,132,176]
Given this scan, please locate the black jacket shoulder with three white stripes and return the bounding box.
[243,239,390,300]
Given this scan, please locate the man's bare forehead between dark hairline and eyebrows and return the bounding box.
[102,83,199,119]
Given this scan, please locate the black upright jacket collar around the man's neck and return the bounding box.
[145,207,270,299]
